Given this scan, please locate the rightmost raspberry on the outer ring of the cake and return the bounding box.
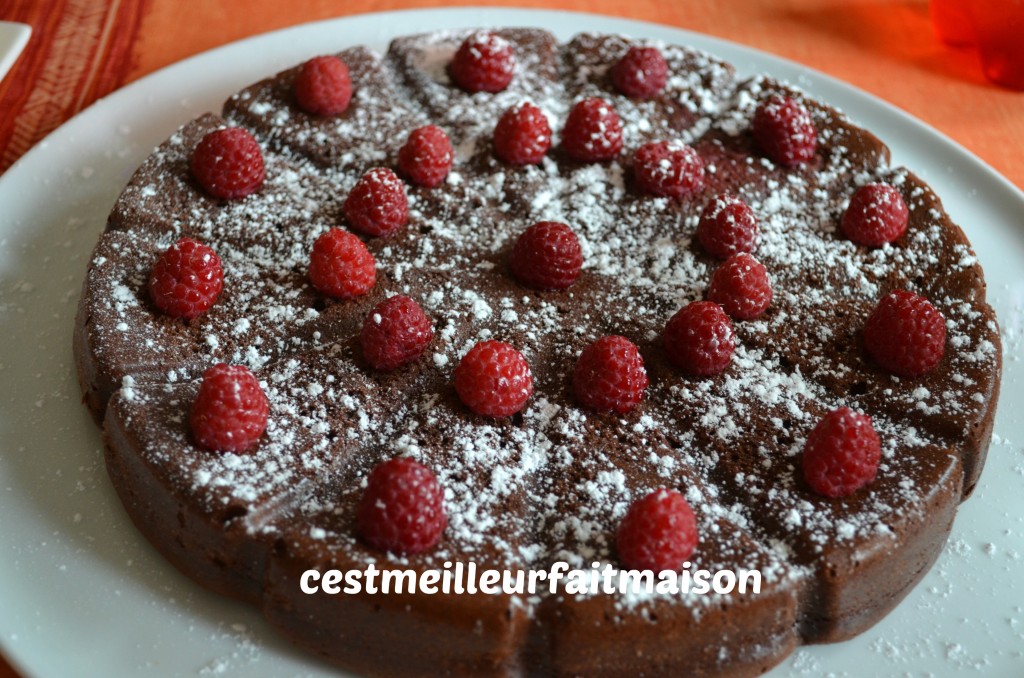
[864,290,946,377]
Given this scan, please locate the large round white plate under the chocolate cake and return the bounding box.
[0,9,1024,677]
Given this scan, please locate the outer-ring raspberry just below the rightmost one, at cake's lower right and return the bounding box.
[803,408,882,498]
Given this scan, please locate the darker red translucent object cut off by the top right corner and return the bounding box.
[965,0,1024,90]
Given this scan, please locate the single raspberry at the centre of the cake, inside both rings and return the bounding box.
[509,221,583,290]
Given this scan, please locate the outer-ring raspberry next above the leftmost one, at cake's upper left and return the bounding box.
[189,127,266,200]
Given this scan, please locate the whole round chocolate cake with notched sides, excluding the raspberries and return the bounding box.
[75,29,1000,676]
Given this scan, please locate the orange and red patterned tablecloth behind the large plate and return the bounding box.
[0,0,1024,678]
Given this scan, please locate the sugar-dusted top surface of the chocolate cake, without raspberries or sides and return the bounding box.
[79,32,997,663]
